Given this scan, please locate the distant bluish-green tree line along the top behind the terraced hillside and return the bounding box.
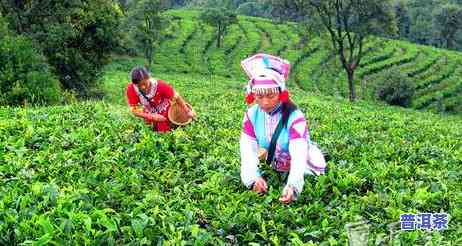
[181,0,462,51]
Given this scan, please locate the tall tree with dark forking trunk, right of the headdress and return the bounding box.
[282,0,396,101]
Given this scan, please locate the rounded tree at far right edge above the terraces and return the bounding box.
[433,4,462,49]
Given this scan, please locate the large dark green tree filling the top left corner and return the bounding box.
[0,0,122,95]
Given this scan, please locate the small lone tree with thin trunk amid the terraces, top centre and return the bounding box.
[200,8,238,48]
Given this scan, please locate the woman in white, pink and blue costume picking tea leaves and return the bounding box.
[240,54,326,203]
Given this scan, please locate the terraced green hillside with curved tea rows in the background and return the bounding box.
[149,11,462,113]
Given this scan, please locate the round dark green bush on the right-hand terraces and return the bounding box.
[376,68,416,107]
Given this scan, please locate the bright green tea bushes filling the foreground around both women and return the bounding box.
[0,56,462,245]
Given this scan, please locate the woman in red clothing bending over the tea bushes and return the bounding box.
[126,67,195,132]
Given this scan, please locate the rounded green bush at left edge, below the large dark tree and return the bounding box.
[0,16,61,105]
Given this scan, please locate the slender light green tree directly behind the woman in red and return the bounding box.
[132,0,169,68]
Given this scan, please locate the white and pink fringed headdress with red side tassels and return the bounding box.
[241,53,290,104]
